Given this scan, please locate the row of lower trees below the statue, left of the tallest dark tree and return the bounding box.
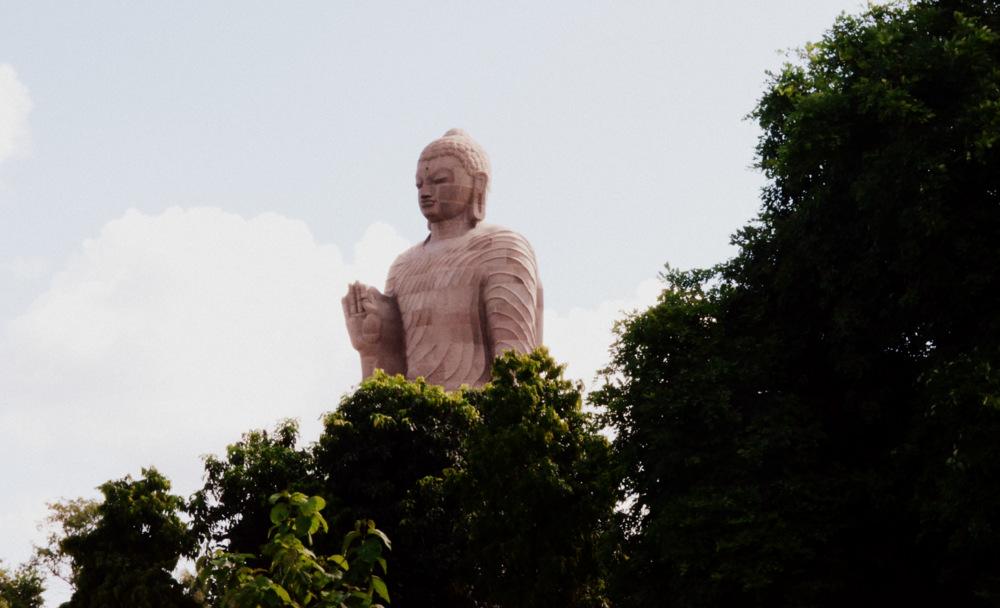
[33,350,616,608]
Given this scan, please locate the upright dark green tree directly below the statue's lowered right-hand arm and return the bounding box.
[451,349,616,607]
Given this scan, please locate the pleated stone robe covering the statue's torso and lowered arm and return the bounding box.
[385,224,542,390]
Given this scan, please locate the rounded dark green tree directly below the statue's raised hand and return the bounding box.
[315,372,478,606]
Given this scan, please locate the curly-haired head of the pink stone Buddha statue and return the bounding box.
[417,129,490,226]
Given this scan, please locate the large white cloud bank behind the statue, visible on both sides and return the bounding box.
[0,208,659,600]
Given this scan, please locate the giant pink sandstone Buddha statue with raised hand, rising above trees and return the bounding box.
[343,129,542,390]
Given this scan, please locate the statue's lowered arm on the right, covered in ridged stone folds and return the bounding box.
[483,232,542,358]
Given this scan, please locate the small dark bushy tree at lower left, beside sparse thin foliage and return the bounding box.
[54,469,195,608]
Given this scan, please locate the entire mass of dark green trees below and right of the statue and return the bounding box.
[0,0,1000,607]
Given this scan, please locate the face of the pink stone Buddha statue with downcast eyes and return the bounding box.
[417,156,475,223]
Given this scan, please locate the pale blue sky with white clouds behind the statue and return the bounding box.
[0,0,862,603]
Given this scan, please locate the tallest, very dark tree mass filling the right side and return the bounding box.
[595,0,1000,605]
